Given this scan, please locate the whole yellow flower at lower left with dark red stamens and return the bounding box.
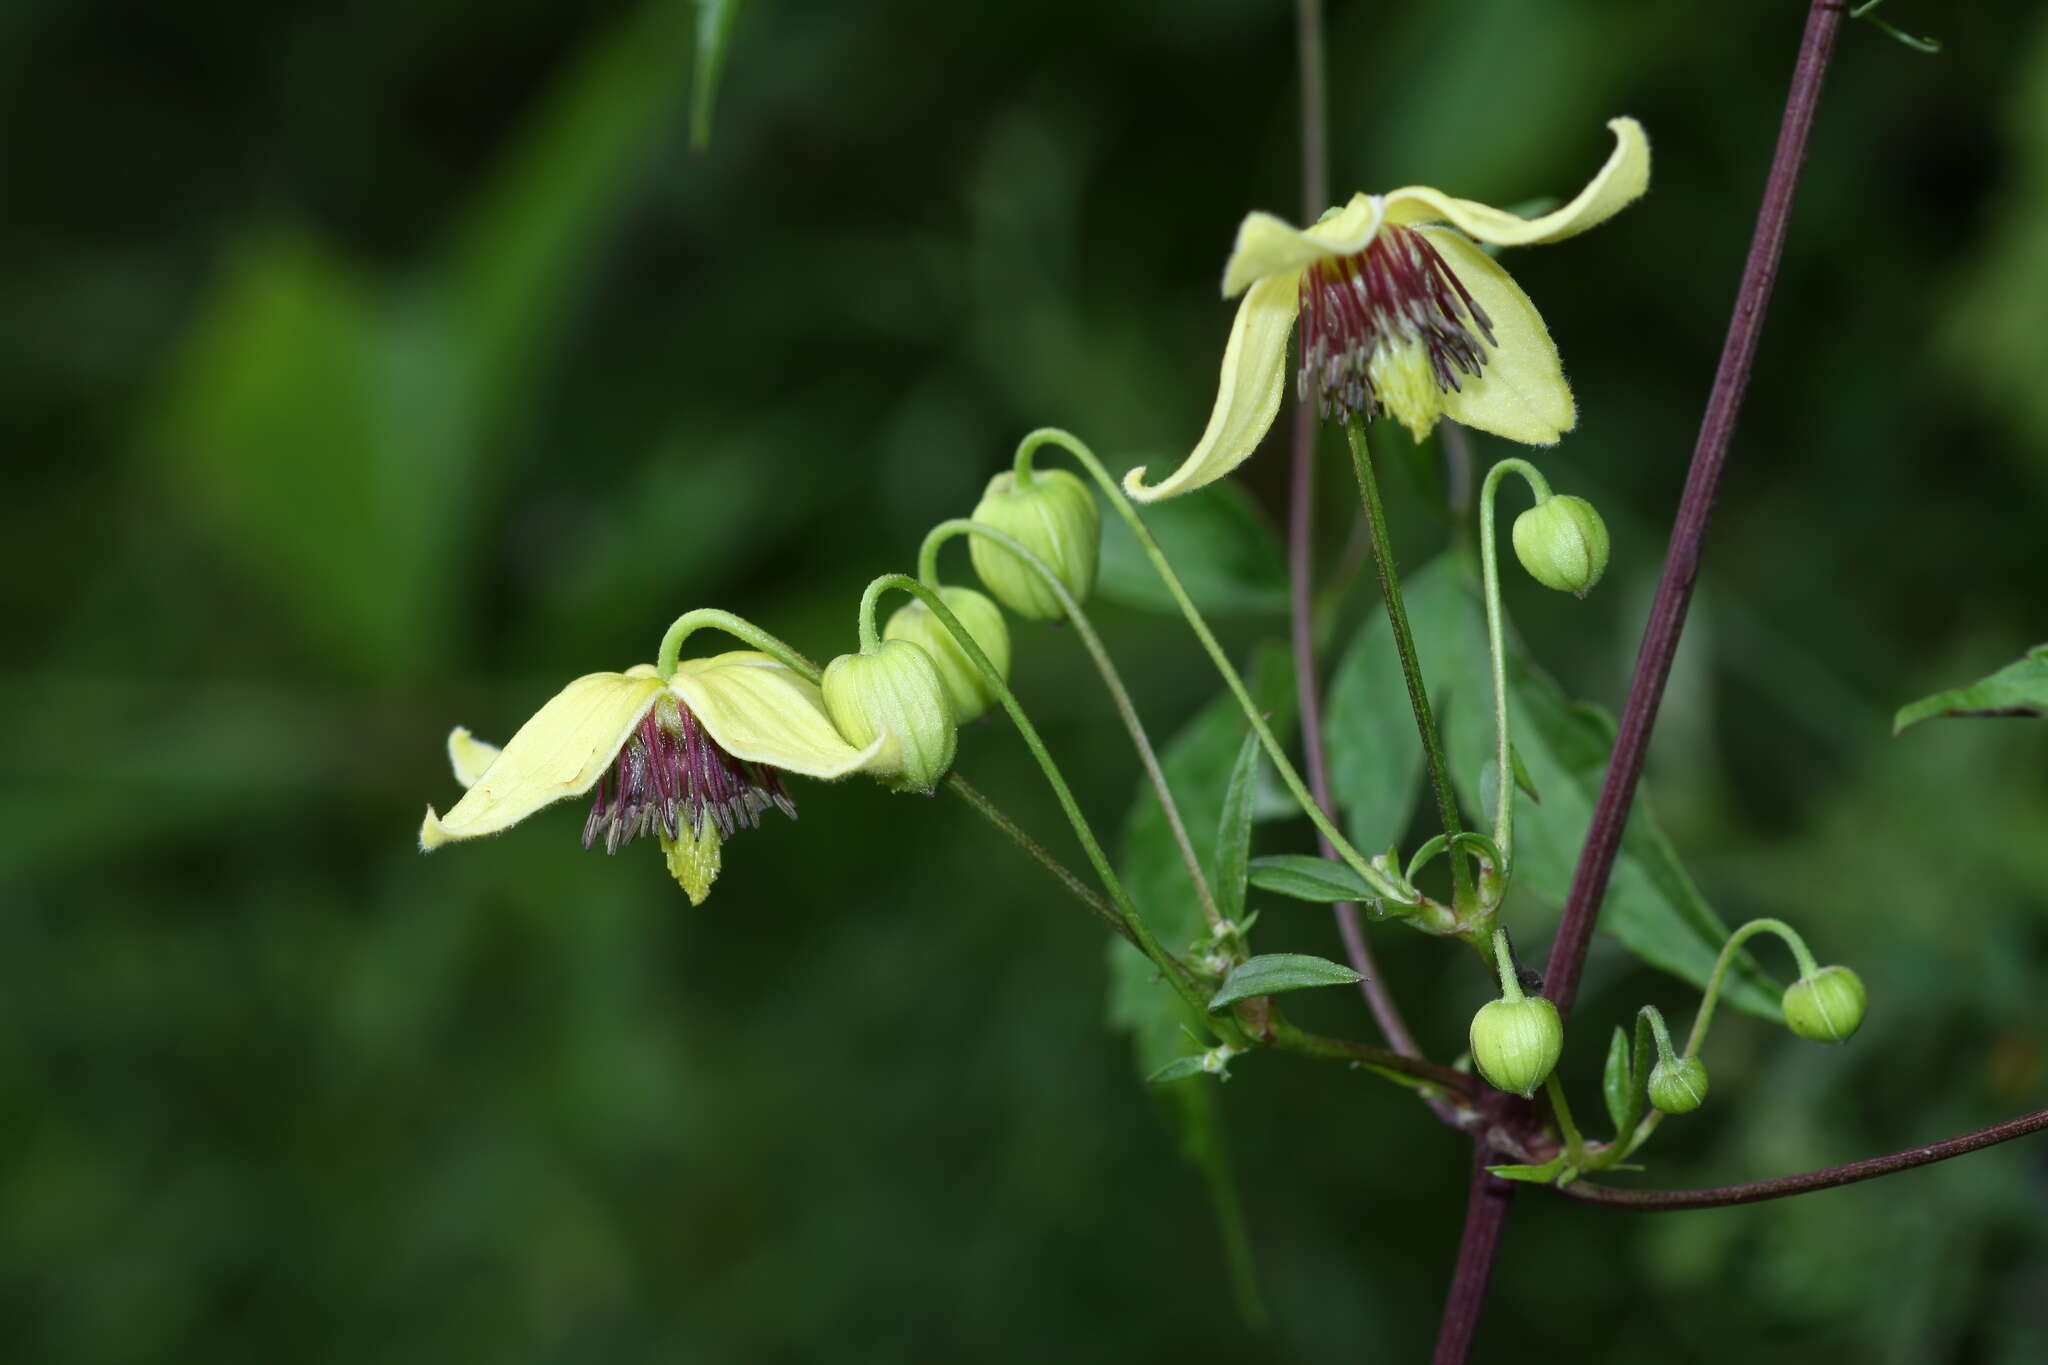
[420,649,887,905]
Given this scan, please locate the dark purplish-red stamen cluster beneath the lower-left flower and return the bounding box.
[584,696,797,853]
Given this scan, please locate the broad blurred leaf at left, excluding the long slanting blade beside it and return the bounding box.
[143,233,469,675]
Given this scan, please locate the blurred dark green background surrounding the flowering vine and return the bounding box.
[0,0,2048,1365]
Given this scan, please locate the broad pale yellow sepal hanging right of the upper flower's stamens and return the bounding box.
[1423,229,1579,446]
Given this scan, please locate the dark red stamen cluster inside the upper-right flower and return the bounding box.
[1298,227,1493,422]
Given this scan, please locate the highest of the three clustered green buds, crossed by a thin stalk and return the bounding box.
[969,469,1102,620]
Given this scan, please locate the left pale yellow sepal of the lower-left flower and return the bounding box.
[420,673,662,849]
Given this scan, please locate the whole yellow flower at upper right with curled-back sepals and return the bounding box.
[1124,119,1651,501]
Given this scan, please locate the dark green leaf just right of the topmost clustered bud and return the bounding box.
[1096,483,1288,616]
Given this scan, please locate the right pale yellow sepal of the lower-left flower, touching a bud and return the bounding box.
[670,649,881,778]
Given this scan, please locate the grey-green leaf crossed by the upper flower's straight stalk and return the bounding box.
[1323,555,1491,849]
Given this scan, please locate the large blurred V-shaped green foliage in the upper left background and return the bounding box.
[143,0,688,677]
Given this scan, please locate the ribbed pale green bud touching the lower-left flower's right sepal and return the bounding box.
[823,641,958,792]
